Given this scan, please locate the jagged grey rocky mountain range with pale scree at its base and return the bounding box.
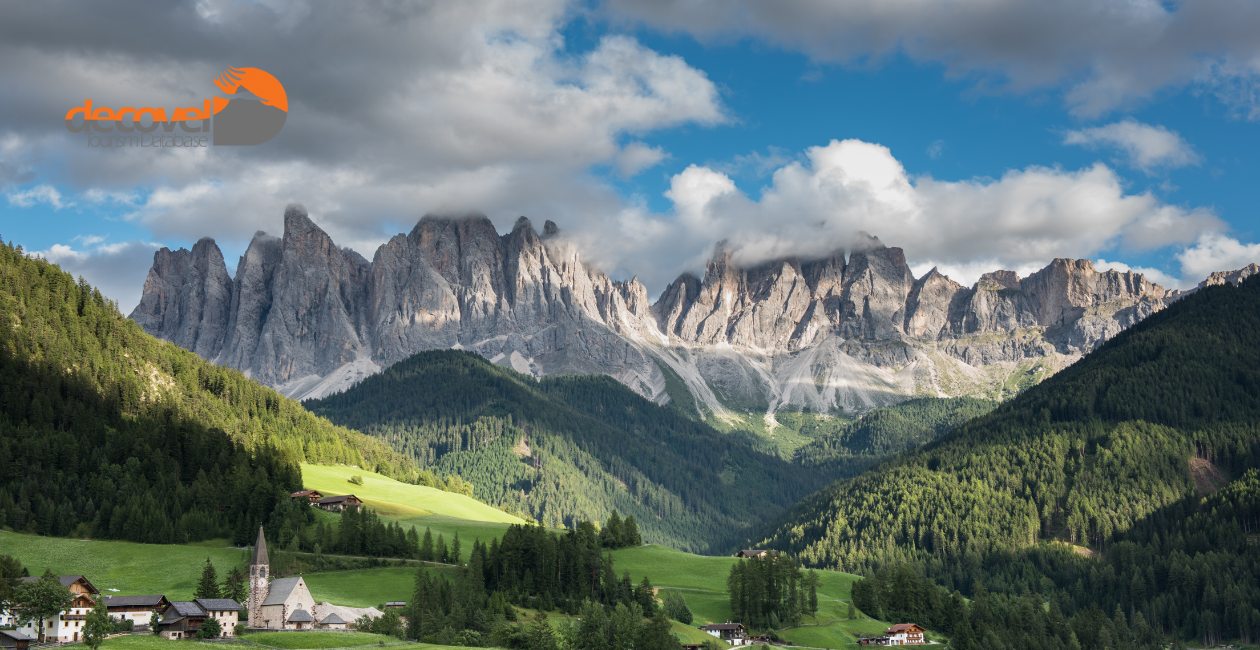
[131,205,1257,426]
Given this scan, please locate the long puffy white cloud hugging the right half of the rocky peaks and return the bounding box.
[575,140,1225,288]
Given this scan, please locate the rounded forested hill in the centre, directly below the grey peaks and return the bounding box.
[306,350,828,552]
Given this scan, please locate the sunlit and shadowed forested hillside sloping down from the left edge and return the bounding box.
[0,238,415,543]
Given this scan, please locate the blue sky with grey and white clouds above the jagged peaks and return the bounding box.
[0,0,1260,310]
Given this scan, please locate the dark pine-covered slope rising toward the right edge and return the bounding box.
[767,280,1260,647]
